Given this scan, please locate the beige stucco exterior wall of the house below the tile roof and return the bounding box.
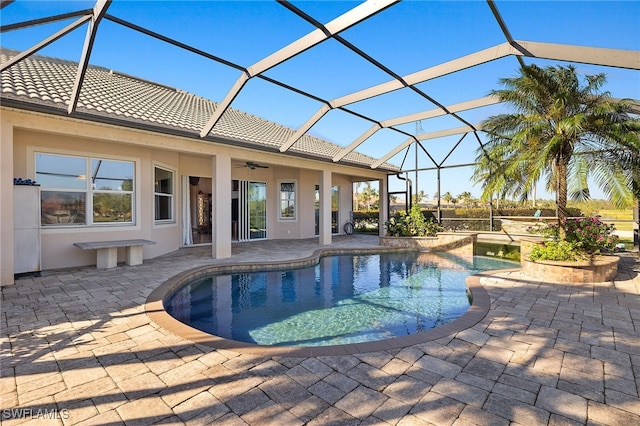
[0,108,385,284]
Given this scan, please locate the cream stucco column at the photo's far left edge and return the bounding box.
[0,120,14,285]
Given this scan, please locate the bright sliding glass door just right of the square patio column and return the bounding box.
[238,180,267,241]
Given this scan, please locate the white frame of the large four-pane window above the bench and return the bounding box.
[33,151,140,228]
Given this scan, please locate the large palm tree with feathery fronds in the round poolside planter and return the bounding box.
[474,65,640,237]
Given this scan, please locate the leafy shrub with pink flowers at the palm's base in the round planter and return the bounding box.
[528,217,618,260]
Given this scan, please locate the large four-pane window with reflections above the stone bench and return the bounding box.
[36,153,135,226]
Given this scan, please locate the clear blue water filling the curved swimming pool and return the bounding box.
[166,252,514,346]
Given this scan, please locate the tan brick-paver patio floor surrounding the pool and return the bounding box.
[0,235,640,426]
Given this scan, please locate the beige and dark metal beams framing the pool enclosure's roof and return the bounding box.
[0,0,640,179]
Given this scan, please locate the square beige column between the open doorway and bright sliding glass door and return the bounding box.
[211,154,231,259]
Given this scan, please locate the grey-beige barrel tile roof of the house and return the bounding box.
[0,48,399,175]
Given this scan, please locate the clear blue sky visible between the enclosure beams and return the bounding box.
[1,0,640,198]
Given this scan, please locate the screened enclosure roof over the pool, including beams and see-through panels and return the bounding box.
[1,0,640,185]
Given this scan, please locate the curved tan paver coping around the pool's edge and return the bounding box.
[144,248,520,357]
